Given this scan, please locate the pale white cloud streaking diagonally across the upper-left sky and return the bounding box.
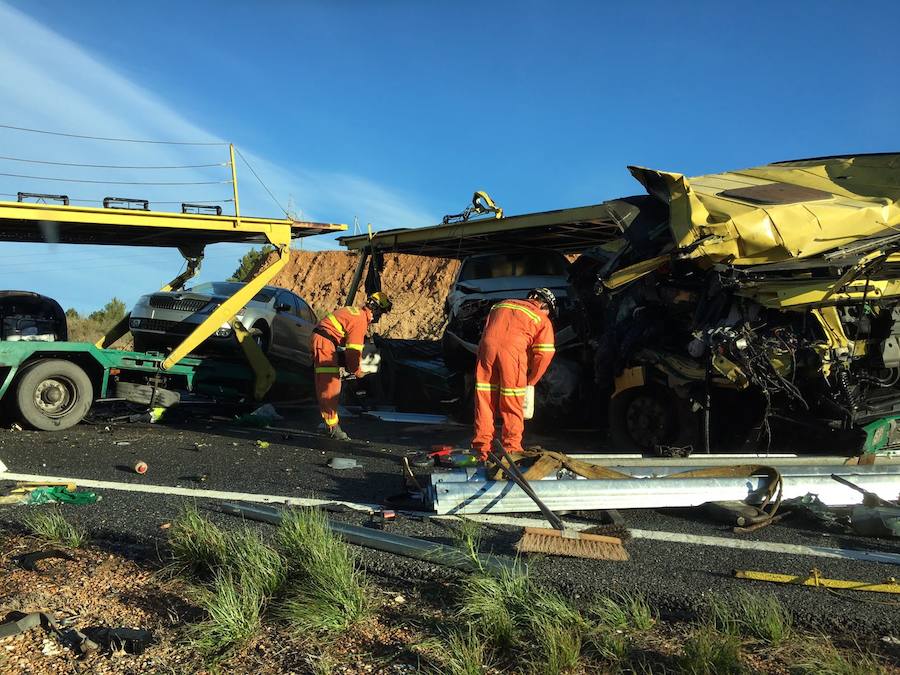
[0,2,436,309]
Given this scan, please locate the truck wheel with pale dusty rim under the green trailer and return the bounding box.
[16,359,94,431]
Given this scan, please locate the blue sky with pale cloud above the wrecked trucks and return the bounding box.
[0,0,900,311]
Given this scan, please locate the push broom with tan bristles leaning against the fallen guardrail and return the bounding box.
[491,440,628,560]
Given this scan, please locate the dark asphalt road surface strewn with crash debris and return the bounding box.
[0,406,900,640]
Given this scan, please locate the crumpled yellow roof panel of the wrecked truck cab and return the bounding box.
[629,154,900,265]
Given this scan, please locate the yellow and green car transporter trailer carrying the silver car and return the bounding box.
[0,184,347,430]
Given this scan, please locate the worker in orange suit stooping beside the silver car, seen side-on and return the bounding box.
[311,291,392,441]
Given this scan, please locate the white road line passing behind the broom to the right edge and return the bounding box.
[466,515,900,565]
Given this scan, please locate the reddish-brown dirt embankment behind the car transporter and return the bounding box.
[269,251,459,339]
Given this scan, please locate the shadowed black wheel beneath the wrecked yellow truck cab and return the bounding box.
[609,385,691,451]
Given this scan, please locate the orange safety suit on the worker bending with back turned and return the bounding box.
[472,300,556,460]
